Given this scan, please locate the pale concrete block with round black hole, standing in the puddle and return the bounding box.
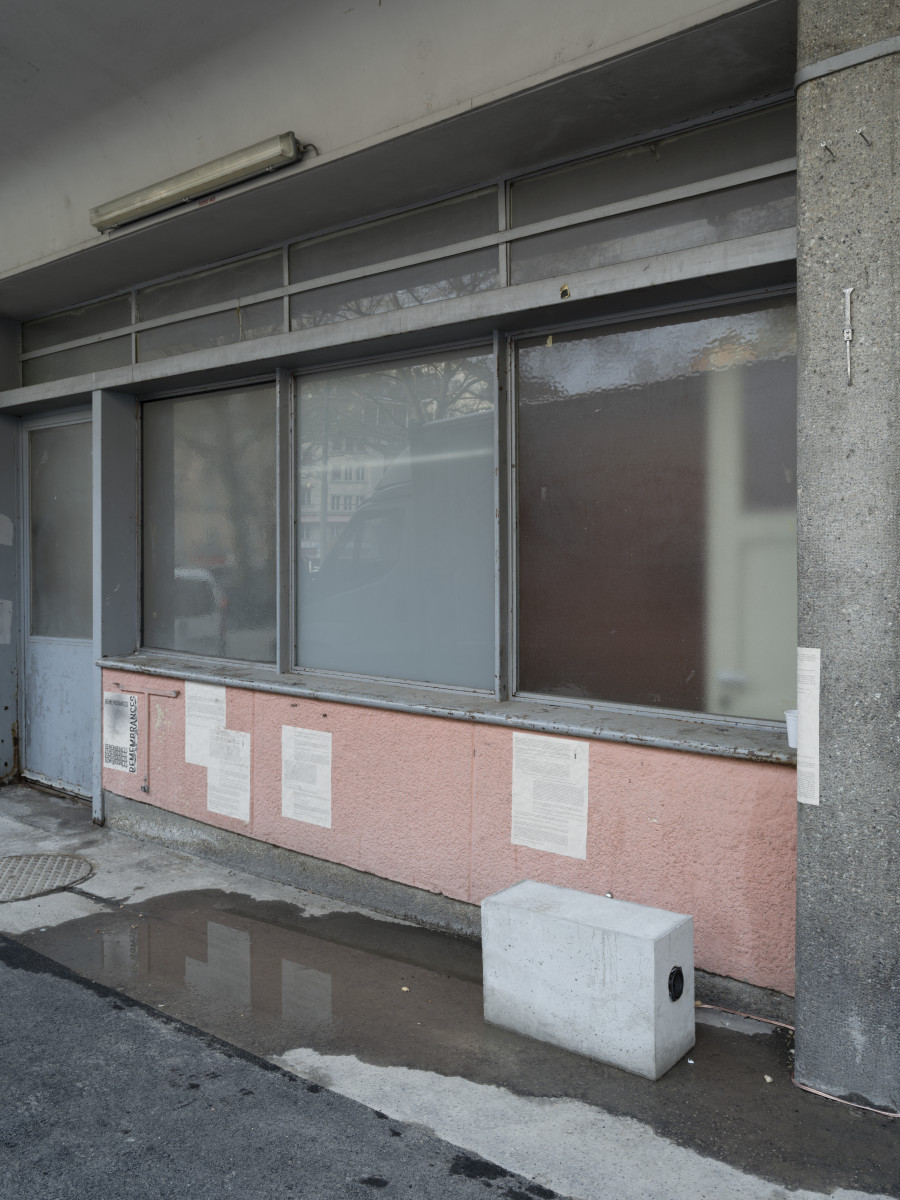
[481,880,695,1079]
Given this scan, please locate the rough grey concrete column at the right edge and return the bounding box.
[796,7,900,1110]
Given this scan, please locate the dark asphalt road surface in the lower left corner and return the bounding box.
[0,937,556,1200]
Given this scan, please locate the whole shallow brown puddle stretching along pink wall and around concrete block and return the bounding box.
[22,890,896,1190]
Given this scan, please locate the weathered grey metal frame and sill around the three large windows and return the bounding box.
[102,284,796,763]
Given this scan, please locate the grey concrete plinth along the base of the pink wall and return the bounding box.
[103,791,793,1025]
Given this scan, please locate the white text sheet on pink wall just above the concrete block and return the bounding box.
[512,733,589,858]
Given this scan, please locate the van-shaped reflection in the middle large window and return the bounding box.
[300,409,493,679]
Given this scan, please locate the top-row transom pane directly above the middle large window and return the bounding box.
[289,187,497,283]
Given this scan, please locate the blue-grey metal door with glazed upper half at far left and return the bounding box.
[22,412,94,796]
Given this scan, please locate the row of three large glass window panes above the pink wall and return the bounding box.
[143,299,797,720]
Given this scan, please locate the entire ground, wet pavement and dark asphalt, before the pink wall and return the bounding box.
[0,786,900,1200]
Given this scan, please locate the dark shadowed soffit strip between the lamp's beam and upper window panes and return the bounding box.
[0,0,796,319]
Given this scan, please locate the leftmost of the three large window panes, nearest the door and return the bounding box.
[143,385,276,662]
